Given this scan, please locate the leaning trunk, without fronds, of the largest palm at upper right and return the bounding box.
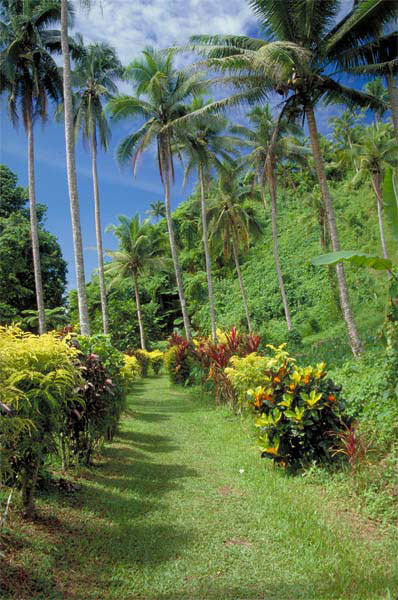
[305,105,362,356]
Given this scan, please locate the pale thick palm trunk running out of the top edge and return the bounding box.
[61,0,90,335]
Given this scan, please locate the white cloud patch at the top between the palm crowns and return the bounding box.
[75,0,256,64]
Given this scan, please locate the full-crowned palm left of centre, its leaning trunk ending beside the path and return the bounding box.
[108,48,205,343]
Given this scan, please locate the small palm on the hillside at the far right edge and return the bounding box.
[354,124,398,258]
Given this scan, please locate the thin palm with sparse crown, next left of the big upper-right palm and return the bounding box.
[231,104,308,331]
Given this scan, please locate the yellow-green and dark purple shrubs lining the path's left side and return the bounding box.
[0,327,138,516]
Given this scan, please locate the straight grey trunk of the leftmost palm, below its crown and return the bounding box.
[26,113,46,335]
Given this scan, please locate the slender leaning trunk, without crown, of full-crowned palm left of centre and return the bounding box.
[159,142,192,345]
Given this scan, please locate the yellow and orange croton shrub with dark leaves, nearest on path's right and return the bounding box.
[225,344,348,469]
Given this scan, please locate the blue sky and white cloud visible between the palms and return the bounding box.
[0,0,366,287]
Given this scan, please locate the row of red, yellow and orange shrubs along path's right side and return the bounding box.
[165,327,350,470]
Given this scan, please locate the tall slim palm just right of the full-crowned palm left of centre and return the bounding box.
[178,97,239,343]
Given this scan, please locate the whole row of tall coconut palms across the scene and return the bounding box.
[0,0,398,355]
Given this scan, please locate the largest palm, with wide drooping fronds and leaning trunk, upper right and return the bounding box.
[187,0,396,356]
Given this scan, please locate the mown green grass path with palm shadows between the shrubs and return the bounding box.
[0,378,398,600]
